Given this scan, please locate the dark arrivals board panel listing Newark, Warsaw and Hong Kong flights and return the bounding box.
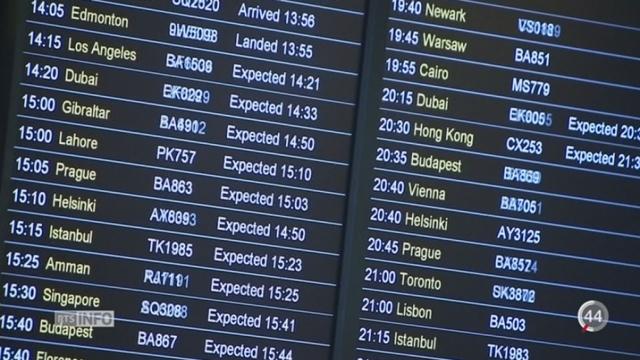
[351,0,640,360]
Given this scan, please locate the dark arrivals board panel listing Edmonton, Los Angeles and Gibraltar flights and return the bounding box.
[0,0,364,360]
